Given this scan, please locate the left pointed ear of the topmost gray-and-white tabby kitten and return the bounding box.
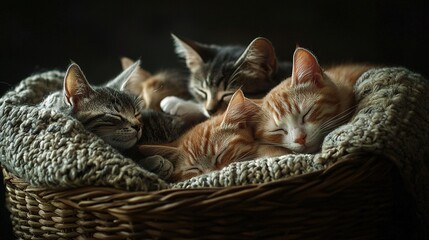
[171,34,204,72]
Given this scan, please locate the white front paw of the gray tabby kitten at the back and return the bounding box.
[160,96,209,124]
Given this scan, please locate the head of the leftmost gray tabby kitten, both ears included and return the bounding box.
[64,63,142,150]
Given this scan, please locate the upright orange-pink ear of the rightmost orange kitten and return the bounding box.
[292,47,323,87]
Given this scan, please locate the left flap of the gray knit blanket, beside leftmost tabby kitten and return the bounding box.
[0,71,167,191]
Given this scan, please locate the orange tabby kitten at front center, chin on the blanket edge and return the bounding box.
[139,90,259,181]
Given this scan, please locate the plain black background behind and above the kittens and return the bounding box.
[0,0,429,239]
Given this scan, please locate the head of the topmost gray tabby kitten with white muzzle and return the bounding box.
[172,35,277,116]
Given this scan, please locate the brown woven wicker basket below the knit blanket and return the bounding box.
[3,155,415,239]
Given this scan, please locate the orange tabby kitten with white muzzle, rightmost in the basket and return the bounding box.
[257,48,373,153]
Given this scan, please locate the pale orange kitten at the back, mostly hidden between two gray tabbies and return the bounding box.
[121,57,191,111]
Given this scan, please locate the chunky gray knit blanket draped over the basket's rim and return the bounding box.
[0,68,429,230]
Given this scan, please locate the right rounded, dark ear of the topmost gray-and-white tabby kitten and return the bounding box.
[235,37,277,76]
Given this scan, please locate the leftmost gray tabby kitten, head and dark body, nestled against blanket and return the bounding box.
[41,61,185,151]
